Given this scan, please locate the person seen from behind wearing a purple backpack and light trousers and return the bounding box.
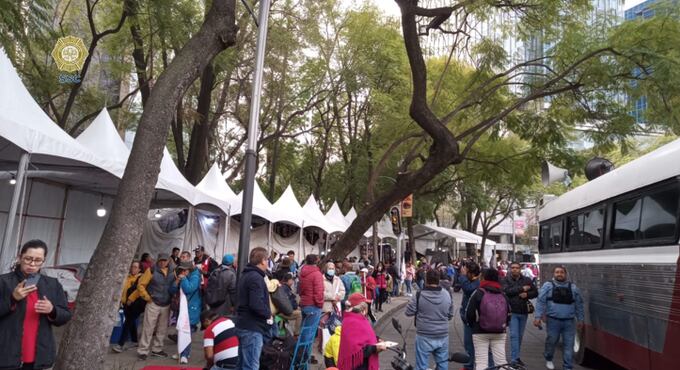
[465,269,511,369]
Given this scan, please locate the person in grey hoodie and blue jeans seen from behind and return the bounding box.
[405,270,453,370]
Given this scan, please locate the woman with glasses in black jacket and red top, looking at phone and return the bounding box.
[0,240,71,369]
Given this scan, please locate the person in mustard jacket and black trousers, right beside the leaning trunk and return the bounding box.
[112,261,146,353]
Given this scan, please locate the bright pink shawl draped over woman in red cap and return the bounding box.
[338,312,380,370]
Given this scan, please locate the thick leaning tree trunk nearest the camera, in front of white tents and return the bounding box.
[54,0,237,370]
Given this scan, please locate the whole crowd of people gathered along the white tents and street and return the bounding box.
[0,240,584,370]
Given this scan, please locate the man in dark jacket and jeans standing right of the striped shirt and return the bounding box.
[236,247,274,370]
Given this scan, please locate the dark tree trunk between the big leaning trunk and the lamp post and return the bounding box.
[184,64,215,185]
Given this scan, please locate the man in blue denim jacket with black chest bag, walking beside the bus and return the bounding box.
[534,266,585,370]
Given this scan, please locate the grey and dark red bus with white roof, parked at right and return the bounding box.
[538,140,680,370]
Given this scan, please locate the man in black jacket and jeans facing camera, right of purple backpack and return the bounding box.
[502,262,538,366]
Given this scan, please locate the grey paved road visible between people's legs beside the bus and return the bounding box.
[376,293,617,370]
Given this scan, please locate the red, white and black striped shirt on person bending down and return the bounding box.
[203,317,238,368]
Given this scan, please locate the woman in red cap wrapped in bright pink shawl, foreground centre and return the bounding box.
[338,293,386,370]
